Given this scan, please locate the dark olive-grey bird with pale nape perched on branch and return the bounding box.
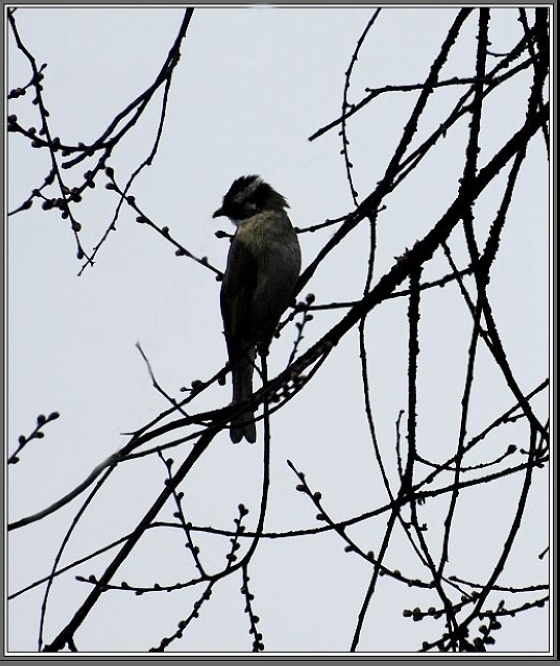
[213,176,301,443]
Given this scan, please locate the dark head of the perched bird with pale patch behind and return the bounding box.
[213,176,289,222]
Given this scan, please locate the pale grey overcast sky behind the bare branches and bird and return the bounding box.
[8,6,549,652]
